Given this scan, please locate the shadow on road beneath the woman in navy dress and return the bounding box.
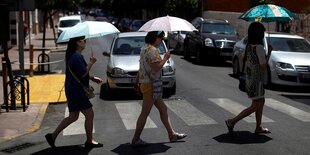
[32,145,91,155]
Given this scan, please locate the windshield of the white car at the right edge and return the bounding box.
[267,37,310,53]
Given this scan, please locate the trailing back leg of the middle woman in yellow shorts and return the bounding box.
[132,100,154,144]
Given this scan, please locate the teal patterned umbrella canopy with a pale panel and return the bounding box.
[239,4,297,22]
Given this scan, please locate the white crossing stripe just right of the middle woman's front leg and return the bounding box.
[165,100,217,126]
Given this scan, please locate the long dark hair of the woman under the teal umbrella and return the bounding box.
[248,22,265,45]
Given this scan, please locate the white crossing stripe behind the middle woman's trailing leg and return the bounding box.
[115,102,157,130]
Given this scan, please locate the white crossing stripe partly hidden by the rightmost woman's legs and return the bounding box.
[209,98,274,123]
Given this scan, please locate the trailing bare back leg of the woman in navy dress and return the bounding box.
[52,111,80,141]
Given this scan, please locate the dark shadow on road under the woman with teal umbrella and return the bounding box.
[213,131,272,144]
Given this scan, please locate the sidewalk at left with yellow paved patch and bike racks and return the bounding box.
[0,29,66,143]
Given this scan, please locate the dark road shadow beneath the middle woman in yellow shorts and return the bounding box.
[112,143,171,155]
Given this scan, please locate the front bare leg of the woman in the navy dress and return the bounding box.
[82,108,97,143]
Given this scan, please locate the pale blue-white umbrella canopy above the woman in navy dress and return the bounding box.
[57,21,120,43]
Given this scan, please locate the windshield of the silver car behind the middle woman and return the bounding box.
[113,36,166,55]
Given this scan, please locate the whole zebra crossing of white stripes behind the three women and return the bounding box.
[63,98,310,135]
